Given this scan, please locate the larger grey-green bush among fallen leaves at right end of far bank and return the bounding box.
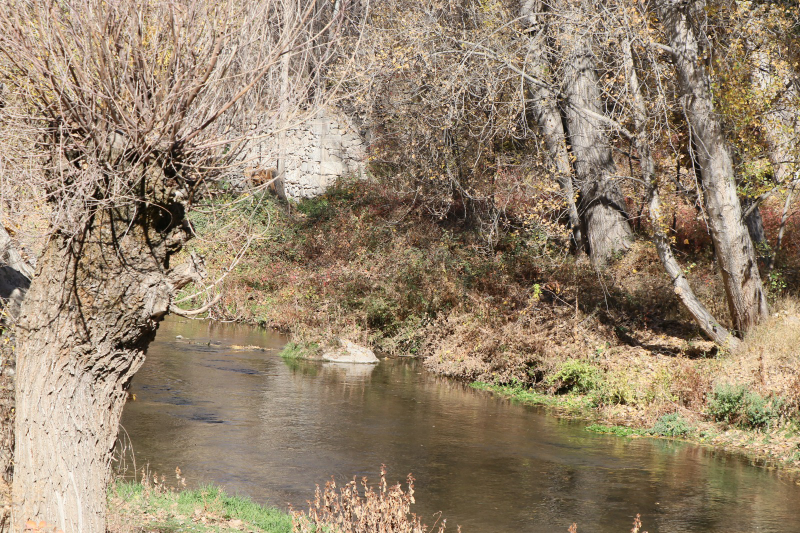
[706,385,781,428]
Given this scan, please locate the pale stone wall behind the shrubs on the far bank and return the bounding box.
[236,110,366,200]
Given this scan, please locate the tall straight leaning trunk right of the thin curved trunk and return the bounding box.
[657,0,768,332]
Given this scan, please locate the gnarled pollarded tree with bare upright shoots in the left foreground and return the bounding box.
[0,0,326,533]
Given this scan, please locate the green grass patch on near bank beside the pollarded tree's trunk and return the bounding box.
[108,482,292,533]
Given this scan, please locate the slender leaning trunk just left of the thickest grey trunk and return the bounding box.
[520,0,585,255]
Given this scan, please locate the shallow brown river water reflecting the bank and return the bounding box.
[117,320,800,533]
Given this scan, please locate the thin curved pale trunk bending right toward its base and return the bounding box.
[622,35,740,349]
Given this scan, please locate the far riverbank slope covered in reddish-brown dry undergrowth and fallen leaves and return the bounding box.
[178,182,800,474]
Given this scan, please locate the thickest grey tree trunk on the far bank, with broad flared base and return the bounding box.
[561,16,633,267]
